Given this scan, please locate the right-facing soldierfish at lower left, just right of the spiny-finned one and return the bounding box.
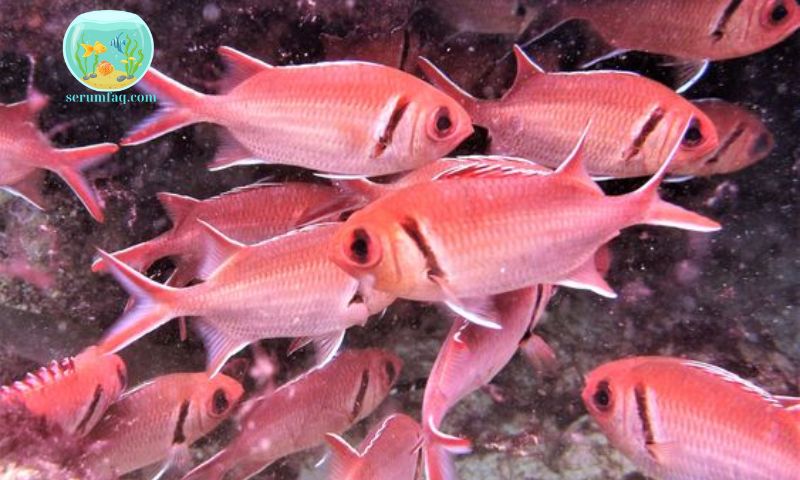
[79,372,243,478]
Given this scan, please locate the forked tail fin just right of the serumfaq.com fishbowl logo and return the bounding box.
[120,68,208,145]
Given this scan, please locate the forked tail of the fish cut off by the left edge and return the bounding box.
[50,143,119,222]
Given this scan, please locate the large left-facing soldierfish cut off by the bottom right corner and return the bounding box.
[583,357,800,480]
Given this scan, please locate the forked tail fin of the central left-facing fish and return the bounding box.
[626,119,722,232]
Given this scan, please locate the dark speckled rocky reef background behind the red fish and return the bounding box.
[0,0,800,480]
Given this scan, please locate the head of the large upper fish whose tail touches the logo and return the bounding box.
[406,86,474,167]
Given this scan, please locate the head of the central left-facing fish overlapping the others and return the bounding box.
[329,208,428,297]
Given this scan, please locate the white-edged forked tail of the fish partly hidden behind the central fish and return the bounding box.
[98,250,180,353]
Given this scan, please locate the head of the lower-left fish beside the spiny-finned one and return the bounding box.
[187,373,244,438]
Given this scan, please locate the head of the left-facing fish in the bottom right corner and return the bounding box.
[581,357,649,458]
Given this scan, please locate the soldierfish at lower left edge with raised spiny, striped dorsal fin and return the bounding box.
[0,347,127,436]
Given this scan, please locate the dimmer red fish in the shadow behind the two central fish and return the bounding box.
[92,182,356,286]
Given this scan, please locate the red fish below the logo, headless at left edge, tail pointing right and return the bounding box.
[0,80,119,222]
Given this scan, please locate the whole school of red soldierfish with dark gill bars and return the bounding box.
[0,0,800,480]
